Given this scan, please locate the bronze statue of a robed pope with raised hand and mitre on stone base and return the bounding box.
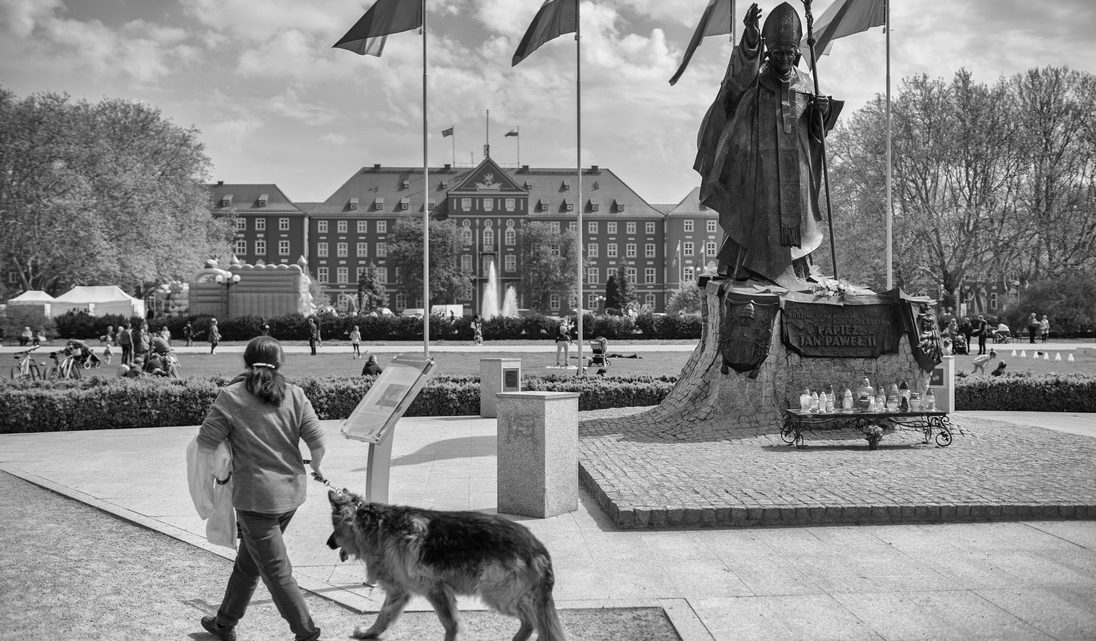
[693,2,843,290]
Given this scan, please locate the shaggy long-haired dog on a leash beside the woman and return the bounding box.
[328,490,566,641]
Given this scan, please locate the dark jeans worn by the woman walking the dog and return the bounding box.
[217,510,320,641]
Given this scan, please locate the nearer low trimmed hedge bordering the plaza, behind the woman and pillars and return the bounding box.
[0,375,1096,434]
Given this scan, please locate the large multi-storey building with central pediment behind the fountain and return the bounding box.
[212,158,720,312]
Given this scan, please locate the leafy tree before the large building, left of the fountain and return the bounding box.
[388,217,471,305]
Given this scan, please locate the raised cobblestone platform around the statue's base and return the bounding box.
[580,409,1096,528]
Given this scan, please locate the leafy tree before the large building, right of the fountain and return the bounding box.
[520,222,579,313]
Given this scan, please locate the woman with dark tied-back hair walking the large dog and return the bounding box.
[197,336,324,641]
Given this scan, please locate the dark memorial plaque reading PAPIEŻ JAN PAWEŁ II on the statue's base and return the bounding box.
[783,300,902,358]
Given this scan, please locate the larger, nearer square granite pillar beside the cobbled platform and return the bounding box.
[498,392,579,518]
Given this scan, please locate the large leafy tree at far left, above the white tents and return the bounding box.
[0,88,232,296]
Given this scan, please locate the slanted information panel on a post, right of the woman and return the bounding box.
[342,355,436,443]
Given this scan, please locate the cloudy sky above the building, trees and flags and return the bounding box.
[0,0,1096,204]
